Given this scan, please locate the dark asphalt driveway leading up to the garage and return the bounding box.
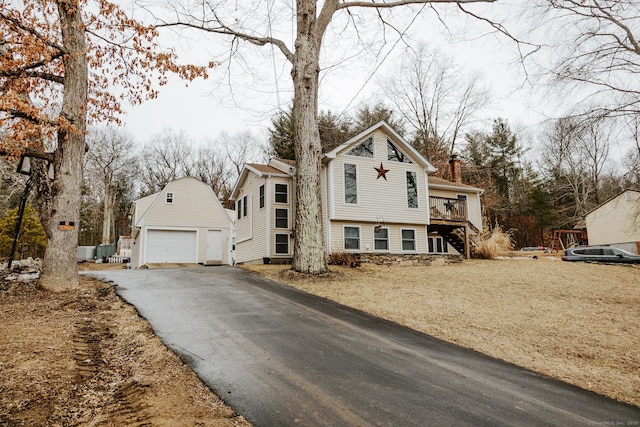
[90,267,640,426]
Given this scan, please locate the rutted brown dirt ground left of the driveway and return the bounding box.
[0,272,250,426]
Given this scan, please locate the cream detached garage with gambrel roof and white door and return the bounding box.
[131,178,233,268]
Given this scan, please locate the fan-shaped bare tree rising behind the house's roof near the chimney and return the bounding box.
[383,45,489,170]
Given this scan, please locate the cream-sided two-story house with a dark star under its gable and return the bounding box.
[231,122,482,263]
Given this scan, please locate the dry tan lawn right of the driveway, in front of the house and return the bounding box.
[246,256,640,406]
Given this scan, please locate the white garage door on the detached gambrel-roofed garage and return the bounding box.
[146,230,198,263]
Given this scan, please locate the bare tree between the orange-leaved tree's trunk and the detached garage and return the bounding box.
[85,128,137,244]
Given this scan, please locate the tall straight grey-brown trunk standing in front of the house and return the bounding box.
[291,0,328,274]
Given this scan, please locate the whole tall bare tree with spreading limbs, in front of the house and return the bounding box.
[160,0,500,274]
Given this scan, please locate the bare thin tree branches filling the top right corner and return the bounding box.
[536,0,640,116]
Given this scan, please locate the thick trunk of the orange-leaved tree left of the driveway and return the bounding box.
[40,0,88,290]
